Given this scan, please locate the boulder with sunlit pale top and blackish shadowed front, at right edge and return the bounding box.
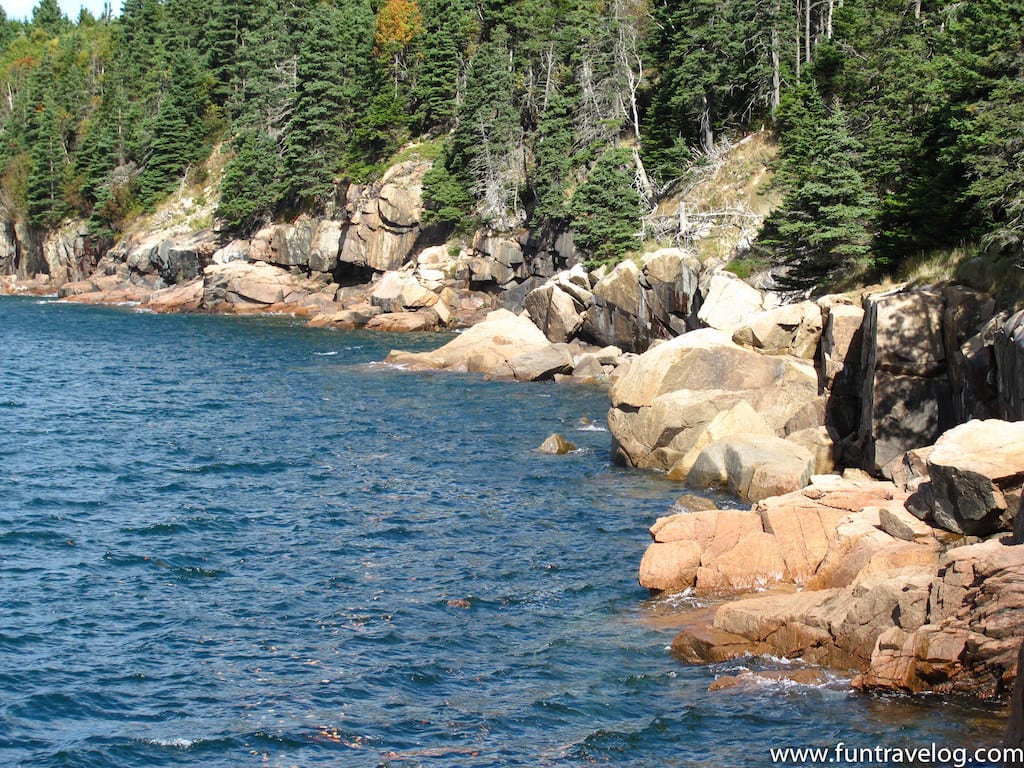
[928,419,1024,536]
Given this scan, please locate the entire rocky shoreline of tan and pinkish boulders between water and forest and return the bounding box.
[0,156,1024,720]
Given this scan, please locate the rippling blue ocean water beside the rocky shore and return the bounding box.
[0,298,1005,768]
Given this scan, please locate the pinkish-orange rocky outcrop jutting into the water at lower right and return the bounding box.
[655,421,1024,698]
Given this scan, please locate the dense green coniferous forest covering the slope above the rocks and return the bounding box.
[0,0,1024,286]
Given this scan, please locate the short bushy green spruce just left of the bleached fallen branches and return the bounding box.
[569,147,641,262]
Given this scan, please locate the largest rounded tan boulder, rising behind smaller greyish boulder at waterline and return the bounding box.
[608,329,818,476]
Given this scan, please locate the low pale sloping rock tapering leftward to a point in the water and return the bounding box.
[387,309,551,374]
